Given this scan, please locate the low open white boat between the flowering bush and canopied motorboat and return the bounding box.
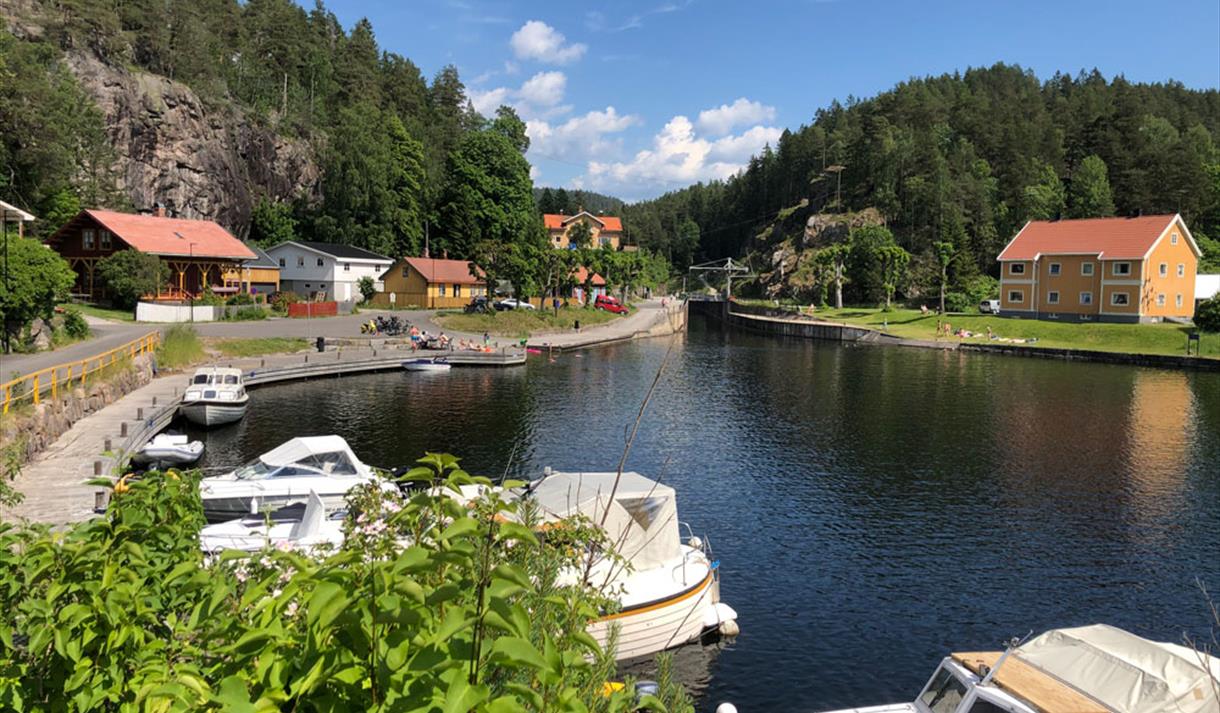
[199,491,346,554]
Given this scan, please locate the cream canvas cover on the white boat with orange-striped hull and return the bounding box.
[532,472,682,570]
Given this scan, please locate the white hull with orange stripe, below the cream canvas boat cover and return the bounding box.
[588,571,719,661]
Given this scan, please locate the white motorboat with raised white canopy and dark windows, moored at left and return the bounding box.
[200,436,398,523]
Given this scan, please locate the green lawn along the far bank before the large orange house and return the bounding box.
[806,308,1220,357]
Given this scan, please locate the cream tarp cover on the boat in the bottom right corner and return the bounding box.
[1016,624,1220,713]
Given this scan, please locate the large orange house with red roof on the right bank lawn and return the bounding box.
[998,215,1200,322]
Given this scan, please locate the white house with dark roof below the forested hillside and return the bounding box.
[267,241,394,303]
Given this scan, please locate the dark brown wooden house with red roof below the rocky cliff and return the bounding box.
[46,209,257,300]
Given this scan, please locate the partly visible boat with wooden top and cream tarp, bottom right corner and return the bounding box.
[819,624,1220,713]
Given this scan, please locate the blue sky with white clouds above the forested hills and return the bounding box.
[312,0,1220,200]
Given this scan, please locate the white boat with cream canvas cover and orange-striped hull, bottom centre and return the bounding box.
[528,472,737,661]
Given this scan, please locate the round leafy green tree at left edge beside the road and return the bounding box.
[0,236,76,352]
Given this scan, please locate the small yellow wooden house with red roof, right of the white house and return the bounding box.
[373,258,487,309]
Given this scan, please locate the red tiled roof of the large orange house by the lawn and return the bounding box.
[998,215,1198,260]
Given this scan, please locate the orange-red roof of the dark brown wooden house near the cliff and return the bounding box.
[75,210,257,260]
